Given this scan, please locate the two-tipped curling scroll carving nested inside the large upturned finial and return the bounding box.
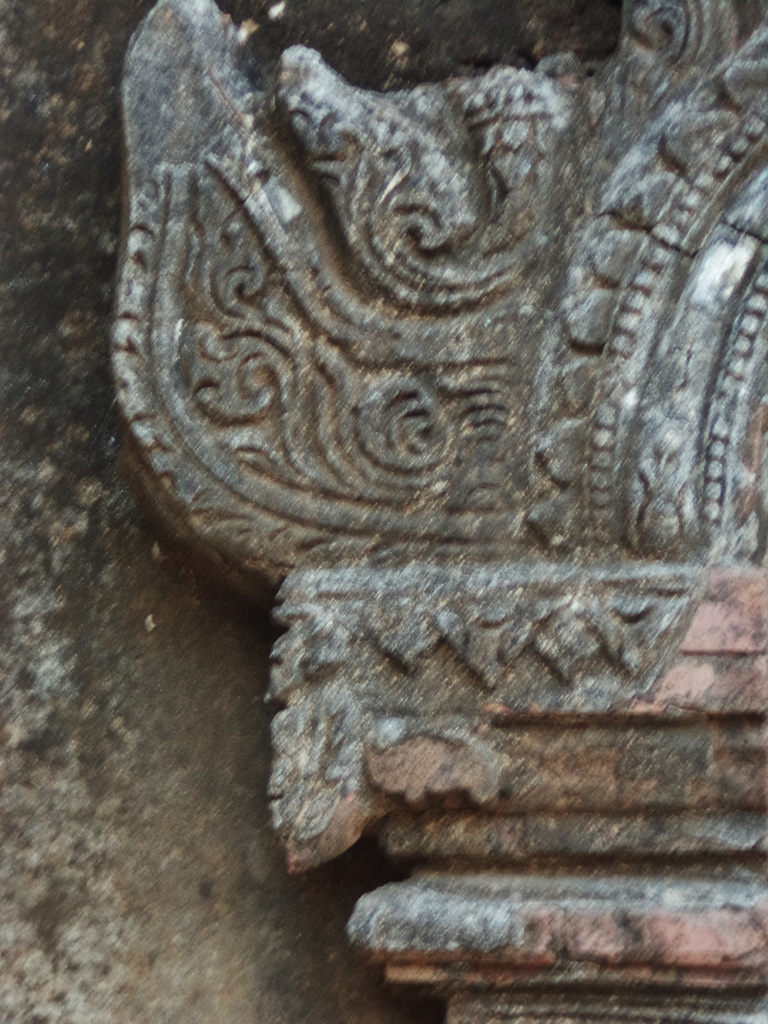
[275,47,574,307]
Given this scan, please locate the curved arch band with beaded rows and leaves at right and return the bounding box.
[530,18,765,555]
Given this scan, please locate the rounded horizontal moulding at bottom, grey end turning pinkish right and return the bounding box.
[349,874,768,988]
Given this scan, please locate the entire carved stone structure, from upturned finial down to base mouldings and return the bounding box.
[114,0,768,1024]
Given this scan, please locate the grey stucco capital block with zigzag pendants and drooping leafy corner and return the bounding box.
[270,565,701,866]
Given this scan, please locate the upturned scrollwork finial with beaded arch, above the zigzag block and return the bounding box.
[116,0,768,581]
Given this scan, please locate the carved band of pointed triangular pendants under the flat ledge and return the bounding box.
[269,564,701,701]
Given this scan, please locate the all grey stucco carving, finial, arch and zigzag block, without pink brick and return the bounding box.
[114,0,768,888]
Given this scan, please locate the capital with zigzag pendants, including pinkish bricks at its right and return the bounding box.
[270,566,768,868]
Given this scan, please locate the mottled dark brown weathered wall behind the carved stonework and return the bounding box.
[0,0,573,1024]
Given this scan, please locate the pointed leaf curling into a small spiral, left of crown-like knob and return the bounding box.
[275,46,481,297]
